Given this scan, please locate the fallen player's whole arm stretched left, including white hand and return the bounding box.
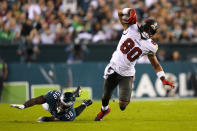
[10,95,46,109]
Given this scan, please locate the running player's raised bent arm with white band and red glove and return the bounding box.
[118,8,137,30]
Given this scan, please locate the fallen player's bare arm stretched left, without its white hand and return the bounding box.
[24,95,46,108]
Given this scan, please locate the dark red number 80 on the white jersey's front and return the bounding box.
[120,38,142,62]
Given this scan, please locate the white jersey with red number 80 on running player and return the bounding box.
[105,24,158,76]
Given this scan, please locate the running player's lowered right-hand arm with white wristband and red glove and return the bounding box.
[148,54,175,88]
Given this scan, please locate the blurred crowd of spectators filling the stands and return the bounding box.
[0,0,197,44]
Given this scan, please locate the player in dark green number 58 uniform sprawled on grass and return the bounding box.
[10,87,92,122]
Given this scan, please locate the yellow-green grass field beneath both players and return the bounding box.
[0,99,197,131]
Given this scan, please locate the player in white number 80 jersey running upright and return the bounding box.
[95,8,174,121]
